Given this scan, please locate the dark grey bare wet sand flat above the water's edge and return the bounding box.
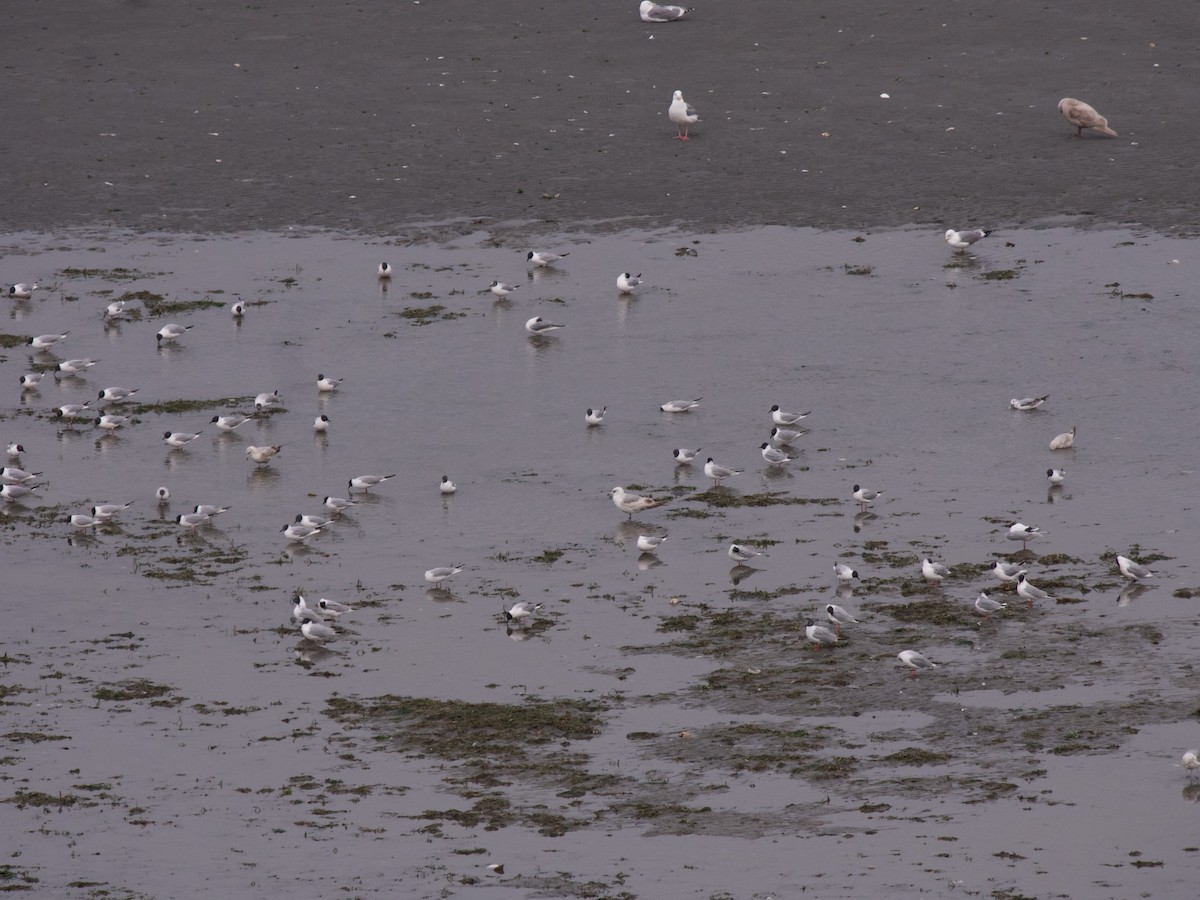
[0,0,1200,235]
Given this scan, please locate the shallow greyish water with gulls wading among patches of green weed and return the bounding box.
[0,222,1200,898]
